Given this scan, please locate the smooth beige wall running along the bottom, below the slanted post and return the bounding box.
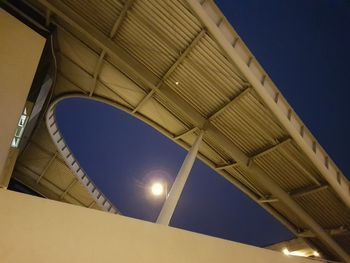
[0,189,314,263]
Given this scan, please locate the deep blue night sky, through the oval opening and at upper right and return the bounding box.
[57,0,350,246]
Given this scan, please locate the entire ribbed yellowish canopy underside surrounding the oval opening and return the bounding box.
[4,0,350,261]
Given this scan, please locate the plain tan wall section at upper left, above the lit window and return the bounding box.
[0,8,45,175]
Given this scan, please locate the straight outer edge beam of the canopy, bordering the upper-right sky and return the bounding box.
[187,0,350,212]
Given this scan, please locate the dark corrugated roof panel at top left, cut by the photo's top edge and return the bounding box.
[62,0,123,36]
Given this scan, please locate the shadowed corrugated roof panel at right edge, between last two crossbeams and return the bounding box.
[296,189,350,229]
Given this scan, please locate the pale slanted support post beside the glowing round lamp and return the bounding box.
[156,130,204,225]
